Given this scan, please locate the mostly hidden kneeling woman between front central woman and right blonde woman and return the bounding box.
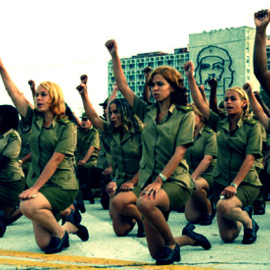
[185,104,217,225]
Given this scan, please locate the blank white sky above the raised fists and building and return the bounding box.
[0,0,270,116]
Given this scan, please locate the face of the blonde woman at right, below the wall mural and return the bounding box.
[224,90,247,115]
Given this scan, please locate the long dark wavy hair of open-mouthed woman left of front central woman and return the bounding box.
[109,98,143,133]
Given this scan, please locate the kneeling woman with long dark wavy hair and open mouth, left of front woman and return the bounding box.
[79,84,144,237]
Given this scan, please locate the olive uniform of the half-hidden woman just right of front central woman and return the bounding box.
[185,126,217,189]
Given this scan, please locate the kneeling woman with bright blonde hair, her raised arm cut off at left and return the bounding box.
[0,58,78,253]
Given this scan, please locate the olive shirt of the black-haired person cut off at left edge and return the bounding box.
[0,129,24,181]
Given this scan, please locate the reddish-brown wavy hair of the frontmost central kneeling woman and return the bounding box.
[147,66,188,106]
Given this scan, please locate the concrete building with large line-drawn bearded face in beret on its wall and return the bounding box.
[108,26,262,104]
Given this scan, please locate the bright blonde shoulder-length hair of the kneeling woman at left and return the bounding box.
[38,81,66,119]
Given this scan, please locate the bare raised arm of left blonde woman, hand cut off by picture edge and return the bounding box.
[0,59,28,117]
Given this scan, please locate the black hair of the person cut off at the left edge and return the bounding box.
[0,105,19,132]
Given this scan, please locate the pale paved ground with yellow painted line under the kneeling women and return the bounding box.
[0,201,270,270]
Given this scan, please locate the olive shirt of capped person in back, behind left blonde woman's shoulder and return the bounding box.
[76,126,100,167]
